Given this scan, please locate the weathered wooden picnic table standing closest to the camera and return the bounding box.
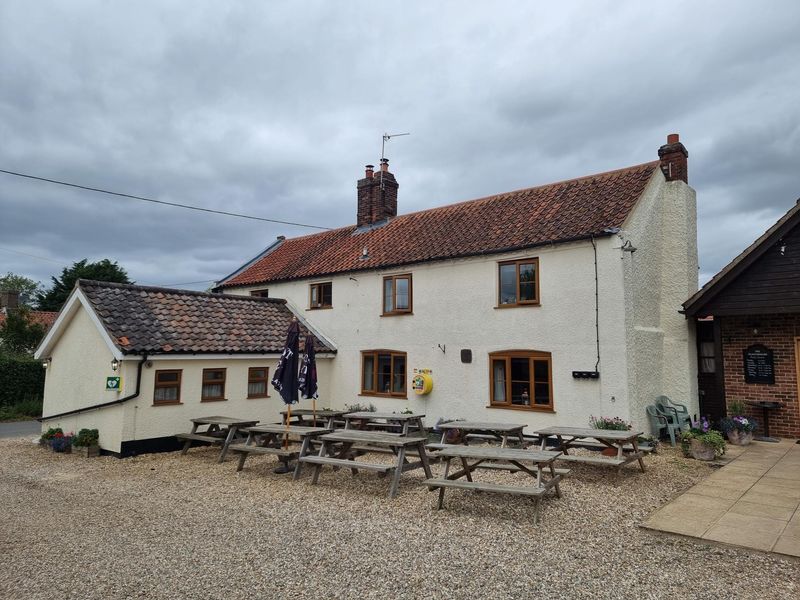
[425,444,568,523]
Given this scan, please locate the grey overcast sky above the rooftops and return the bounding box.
[0,0,800,289]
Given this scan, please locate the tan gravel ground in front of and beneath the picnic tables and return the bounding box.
[0,439,800,600]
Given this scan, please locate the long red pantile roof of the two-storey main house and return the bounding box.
[220,161,660,287]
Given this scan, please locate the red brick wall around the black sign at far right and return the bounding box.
[716,314,800,438]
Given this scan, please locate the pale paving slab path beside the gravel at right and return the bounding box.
[643,440,800,557]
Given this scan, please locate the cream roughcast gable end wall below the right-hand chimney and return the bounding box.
[620,172,698,431]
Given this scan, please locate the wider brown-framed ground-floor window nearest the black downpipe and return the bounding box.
[489,350,553,410]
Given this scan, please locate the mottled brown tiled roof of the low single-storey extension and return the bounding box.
[76,279,336,355]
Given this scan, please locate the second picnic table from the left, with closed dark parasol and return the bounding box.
[228,424,331,479]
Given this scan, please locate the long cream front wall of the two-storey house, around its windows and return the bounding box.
[230,238,628,428]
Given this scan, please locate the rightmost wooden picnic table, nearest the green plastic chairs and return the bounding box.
[536,427,645,472]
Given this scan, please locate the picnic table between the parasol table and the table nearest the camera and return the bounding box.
[296,429,433,498]
